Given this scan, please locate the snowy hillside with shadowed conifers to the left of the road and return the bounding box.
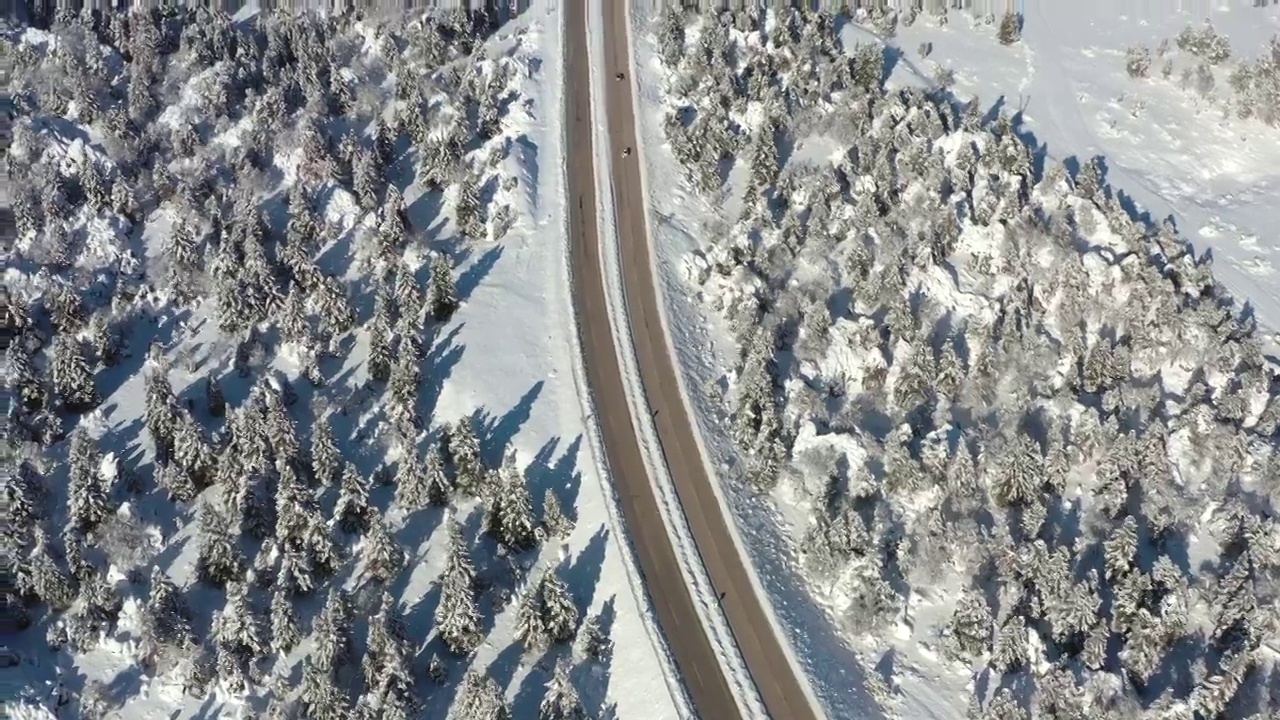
[4,3,684,719]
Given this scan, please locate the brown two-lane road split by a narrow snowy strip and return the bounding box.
[566,0,817,720]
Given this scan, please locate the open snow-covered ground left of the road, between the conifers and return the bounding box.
[5,0,689,720]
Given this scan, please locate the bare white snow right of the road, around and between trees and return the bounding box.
[631,0,1280,719]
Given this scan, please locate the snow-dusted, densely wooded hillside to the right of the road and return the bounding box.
[634,3,1280,719]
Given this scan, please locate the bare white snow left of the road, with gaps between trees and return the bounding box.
[4,0,689,720]
